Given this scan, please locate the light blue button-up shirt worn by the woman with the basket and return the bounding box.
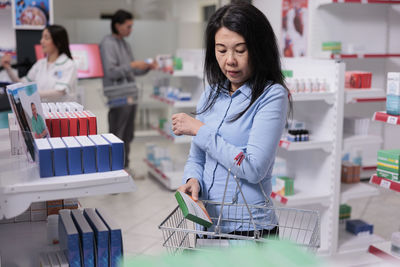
[183,84,288,232]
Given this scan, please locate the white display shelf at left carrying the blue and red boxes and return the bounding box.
[0,129,135,266]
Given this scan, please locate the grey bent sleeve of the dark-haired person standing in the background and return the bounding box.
[100,40,132,80]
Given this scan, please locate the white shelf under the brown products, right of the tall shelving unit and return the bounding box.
[340,183,379,204]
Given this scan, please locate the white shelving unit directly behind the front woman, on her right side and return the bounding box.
[275,58,344,254]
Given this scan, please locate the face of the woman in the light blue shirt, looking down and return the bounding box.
[215,27,252,91]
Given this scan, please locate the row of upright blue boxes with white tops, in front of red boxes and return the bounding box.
[35,134,124,178]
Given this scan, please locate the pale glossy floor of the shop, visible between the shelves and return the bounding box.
[80,81,400,266]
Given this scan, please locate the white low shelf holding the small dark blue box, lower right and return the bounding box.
[338,223,384,253]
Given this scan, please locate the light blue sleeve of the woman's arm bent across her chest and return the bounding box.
[192,86,288,183]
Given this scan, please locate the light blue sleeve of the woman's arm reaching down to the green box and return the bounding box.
[182,89,206,196]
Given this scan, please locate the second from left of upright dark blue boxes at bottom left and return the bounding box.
[71,210,95,267]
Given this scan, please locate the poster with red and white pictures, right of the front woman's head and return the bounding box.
[281,0,308,57]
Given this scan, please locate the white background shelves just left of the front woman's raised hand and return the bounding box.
[144,70,203,190]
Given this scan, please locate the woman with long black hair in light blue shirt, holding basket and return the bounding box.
[172,3,291,235]
